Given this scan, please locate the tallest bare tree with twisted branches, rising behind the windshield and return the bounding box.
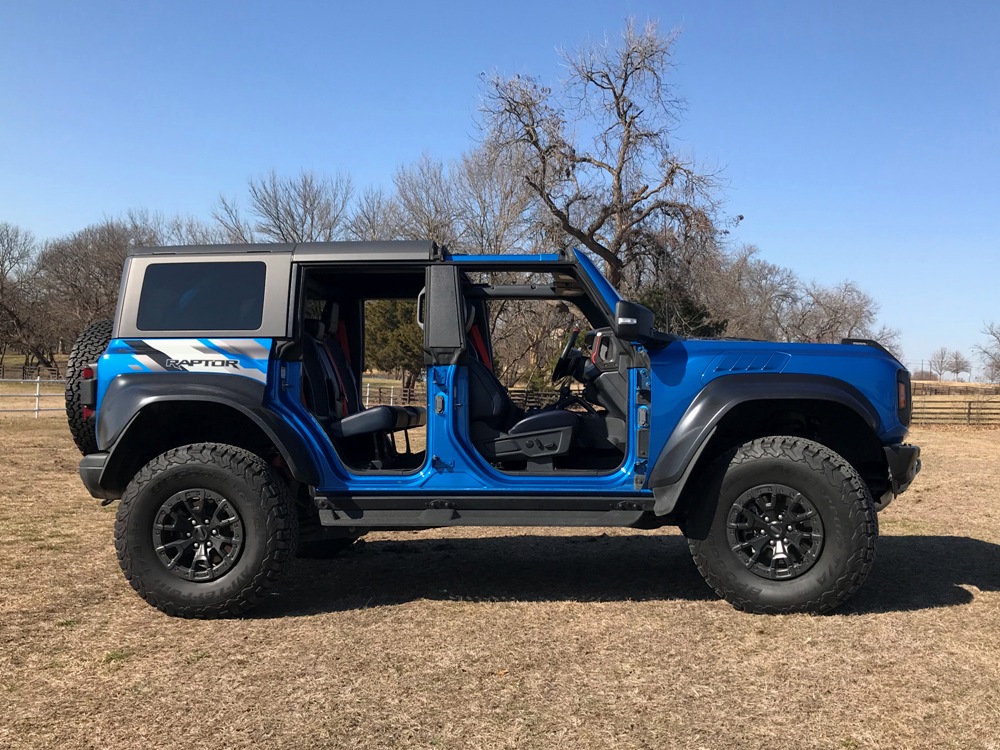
[482,20,714,285]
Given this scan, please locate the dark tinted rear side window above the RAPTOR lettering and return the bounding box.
[136,262,265,331]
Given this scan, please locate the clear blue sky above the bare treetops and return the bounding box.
[0,0,1000,366]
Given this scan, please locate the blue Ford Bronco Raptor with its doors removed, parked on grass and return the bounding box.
[67,242,920,617]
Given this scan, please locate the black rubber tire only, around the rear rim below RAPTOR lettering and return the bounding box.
[115,443,298,619]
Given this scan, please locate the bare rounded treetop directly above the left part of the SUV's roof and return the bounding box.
[212,170,354,242]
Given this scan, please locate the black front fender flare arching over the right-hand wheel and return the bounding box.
[646,373,881,515]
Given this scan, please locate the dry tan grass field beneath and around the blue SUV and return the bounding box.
[0,415,1000,750]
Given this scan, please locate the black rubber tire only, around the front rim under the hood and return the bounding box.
[688,437,878,614]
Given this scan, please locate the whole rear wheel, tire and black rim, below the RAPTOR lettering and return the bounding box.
[115,443,298,618]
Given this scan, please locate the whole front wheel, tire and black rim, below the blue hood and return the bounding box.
[688,437,878,614]
